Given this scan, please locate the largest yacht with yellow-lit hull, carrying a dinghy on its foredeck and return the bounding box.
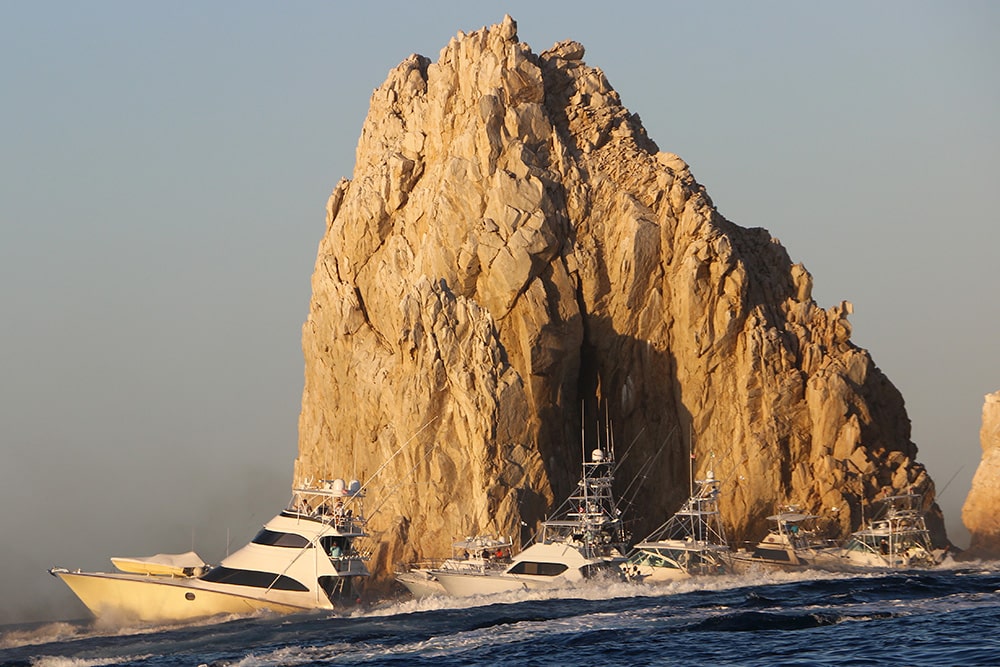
[49,479,369,623]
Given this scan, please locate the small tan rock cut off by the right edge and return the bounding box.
[962,391,1000,559]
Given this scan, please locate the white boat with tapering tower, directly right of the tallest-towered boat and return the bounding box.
[622,470,732,582]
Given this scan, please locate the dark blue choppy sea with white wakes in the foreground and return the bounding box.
[0,563,1000,667]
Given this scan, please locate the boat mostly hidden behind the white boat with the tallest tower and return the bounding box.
[396,535,514,598]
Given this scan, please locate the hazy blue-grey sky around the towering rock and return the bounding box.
[0,0,1000,622]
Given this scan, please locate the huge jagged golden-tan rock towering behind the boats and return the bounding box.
[295,17,944,570]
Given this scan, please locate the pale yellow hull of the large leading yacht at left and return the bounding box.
[52,570,308,623]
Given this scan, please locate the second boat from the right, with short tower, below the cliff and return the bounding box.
[732,505,841,571]
